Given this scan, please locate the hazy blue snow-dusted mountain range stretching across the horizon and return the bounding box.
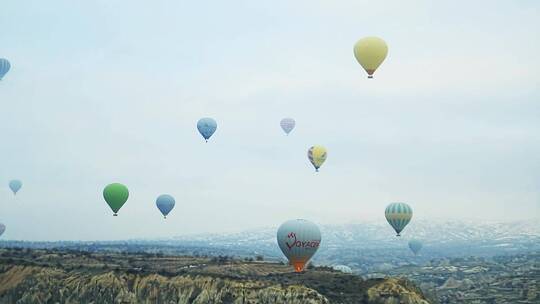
[0,220,540,273]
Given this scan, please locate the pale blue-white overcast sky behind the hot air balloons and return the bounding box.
[0,0,540,240]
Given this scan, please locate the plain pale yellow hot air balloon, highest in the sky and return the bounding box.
[354,37,388,78]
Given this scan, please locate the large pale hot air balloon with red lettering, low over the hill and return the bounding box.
[277,219,321,272]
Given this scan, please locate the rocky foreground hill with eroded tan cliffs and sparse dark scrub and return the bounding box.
[0,249,428,304]
